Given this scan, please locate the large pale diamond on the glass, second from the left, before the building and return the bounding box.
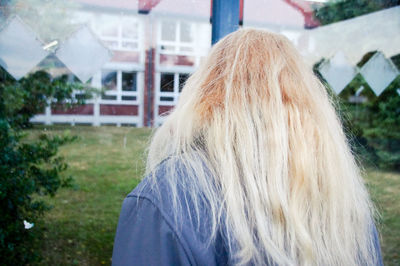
[56,27,111,82]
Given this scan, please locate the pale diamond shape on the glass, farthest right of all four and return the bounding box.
[360,52,399,96]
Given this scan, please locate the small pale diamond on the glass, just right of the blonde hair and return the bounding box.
[319,51,357,94]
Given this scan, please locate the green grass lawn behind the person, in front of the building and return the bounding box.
[27,127,400,265]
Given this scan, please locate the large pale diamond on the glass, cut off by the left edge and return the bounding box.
[0,17,48,80]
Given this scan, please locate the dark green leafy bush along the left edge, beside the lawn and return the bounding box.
[0,69,92,265]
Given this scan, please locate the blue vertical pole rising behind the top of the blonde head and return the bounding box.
[211,0,240,44]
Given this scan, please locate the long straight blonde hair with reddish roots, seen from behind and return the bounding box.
[147,29,377,265]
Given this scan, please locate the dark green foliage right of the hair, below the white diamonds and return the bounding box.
[314,57,400,170]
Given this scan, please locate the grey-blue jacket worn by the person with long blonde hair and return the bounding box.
[112,159,382,266]
